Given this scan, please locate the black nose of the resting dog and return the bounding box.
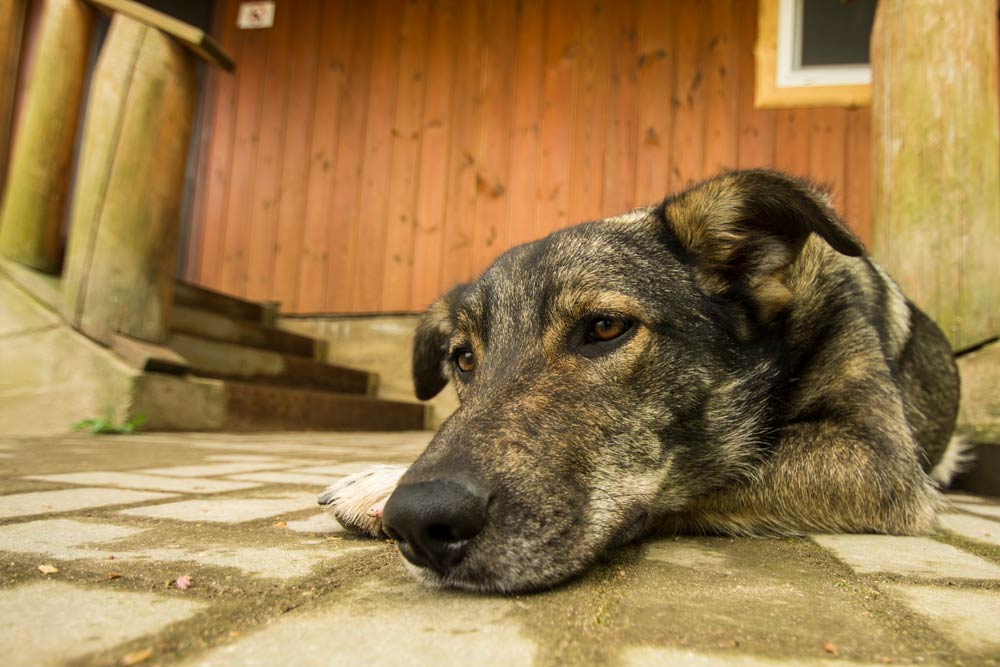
[382,479,487,574]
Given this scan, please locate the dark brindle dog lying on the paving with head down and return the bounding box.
[320,170,962,593]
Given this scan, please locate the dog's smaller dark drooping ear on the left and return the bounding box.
[413,284,469,401]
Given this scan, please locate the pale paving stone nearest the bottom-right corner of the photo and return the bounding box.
[889,585,1000,656]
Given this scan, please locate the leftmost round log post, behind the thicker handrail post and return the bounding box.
[0,0,93,273]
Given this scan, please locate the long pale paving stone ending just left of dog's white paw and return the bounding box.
[119,493,316,523]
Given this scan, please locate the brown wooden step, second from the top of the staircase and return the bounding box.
[170,304,321,359]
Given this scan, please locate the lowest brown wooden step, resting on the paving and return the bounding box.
[223,381,428,432]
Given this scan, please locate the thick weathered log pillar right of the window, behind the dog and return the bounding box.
[872,0,1000,350]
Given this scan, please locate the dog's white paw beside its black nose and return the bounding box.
[319,465,406,537]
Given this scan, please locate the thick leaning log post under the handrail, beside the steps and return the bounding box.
[63,13,197,343]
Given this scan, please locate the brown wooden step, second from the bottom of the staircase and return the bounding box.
[168,333,378,395]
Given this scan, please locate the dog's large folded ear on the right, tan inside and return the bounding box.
[663,169,865,323]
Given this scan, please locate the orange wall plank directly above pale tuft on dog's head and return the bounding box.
[601,2,639,216]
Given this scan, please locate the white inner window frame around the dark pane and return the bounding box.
[775,0,872,88]
